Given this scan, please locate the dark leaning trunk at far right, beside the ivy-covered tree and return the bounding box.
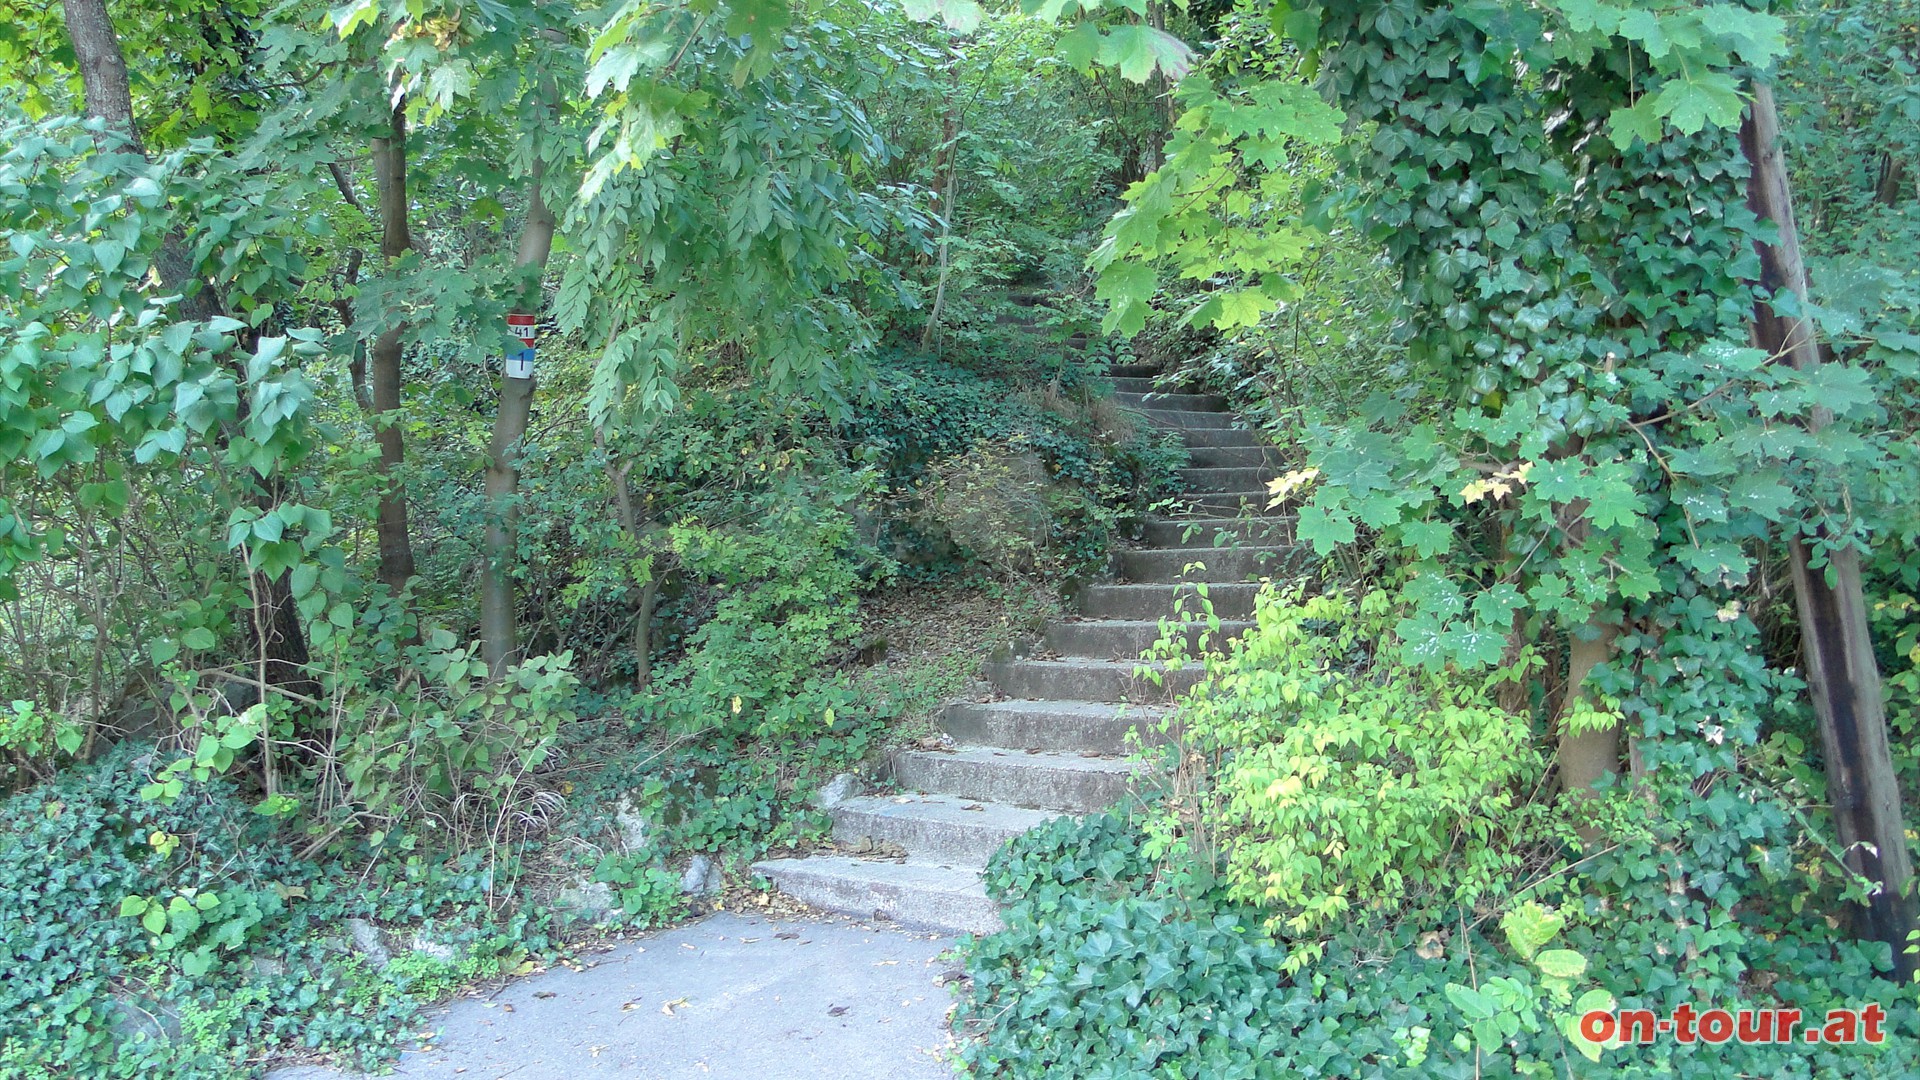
[1740,83,1914,982]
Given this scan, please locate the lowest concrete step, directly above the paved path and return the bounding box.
[753,855,1000,934]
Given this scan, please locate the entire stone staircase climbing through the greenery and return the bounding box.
[755,357,1292,934]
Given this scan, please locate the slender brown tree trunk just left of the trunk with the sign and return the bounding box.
[367,100,413,594]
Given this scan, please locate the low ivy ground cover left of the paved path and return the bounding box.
[0,749,545,1080]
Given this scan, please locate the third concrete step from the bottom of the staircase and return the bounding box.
[893,746,1140,813]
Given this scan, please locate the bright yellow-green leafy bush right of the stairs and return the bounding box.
[1154,588,1546,963]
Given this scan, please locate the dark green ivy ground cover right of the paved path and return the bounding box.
[958,815,1920,1080]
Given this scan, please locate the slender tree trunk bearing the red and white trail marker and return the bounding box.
[480,154,555,678]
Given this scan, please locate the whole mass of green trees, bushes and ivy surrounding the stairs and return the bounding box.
[0,0,1920,1078]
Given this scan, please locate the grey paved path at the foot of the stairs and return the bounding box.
[269,913,958,1080]
